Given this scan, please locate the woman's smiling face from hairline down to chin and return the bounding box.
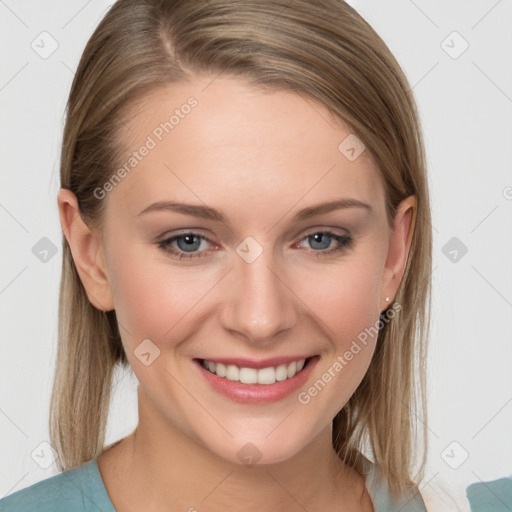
[84,78,411,463]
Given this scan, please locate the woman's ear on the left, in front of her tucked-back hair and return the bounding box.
[57,188,114,311]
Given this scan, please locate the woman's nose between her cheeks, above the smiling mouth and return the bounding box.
[220,245,300,344]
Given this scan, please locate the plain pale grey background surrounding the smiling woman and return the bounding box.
[0,0,512,511]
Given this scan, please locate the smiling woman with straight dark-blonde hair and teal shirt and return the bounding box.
[0,0,431,512]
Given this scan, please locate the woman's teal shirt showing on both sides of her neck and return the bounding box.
[0,459,427,512]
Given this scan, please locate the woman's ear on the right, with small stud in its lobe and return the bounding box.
[380,196,416,311]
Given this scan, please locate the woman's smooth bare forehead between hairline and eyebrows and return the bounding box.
[111,77,384,217]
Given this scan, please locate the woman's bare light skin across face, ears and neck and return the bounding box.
[58,77,415,512]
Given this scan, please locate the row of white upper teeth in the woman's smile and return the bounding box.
[203,359,306,384]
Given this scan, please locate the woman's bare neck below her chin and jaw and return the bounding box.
[98,386,364,512]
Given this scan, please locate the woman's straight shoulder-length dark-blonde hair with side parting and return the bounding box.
[50,0,432,502]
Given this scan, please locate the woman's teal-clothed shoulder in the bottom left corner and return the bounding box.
[0,460,113,512]
